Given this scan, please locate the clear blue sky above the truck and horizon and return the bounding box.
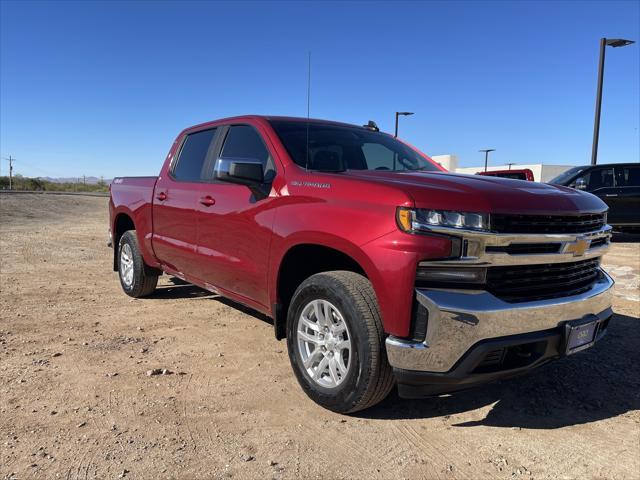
[0,1,640,178]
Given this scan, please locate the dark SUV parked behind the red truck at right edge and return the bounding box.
[549,163,640,233]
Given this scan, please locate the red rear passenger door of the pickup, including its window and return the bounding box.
[152,128,217,278]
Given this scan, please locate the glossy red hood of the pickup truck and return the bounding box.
[349,170,607,215]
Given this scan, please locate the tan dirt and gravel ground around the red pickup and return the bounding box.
[0,195,640,479]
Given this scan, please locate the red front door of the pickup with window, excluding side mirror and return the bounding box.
[192,124,277,307]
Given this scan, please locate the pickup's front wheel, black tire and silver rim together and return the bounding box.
[287,271,394,413]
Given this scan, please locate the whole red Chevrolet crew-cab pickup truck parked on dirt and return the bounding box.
[109,115,613,413]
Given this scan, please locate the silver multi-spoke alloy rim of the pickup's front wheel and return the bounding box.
[296,300,352,388]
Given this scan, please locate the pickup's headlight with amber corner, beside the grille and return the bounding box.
[396,207,489,233]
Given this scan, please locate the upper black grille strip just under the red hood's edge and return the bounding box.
[491,213,605,233]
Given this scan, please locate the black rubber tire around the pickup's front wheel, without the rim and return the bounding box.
[287,271,395,413]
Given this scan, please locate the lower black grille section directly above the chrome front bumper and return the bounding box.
[487,258,600,302]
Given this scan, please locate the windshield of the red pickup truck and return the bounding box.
[270,120,439,172]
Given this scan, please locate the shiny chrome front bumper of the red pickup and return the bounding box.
[386,271,614,372]
